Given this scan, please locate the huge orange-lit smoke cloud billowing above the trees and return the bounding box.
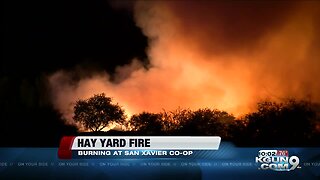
[49,1,320,123]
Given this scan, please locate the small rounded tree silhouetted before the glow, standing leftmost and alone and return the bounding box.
[73,93,126,131]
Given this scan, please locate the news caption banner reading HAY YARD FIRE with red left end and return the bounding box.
[58,136,221,159]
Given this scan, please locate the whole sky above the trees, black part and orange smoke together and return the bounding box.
[0,0,320,146]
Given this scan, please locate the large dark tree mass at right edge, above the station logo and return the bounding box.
[240,100,319,146]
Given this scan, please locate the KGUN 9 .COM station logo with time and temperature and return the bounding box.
[256,150,300,171]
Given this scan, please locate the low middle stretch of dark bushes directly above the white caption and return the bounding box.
[129,108,247,141]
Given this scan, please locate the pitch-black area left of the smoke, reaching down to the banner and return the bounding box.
[0,0,148,146]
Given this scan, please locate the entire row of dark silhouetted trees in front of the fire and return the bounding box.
[74,94,320,146]
